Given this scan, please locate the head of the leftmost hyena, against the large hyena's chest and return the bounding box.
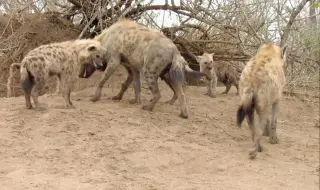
[77,39,104,78]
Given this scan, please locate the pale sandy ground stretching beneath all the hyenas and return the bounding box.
[0,71,319,190]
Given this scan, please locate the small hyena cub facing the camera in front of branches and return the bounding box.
[196,53,244,98]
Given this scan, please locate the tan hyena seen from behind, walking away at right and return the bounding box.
[237,43,287,158]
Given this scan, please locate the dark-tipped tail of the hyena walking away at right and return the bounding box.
[237,87,256,127]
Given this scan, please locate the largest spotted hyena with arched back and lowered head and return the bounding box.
[87,19,201,118]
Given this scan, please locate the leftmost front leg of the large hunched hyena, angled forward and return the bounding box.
[91,55,121,102]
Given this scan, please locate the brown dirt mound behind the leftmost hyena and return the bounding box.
[0,13,80,97]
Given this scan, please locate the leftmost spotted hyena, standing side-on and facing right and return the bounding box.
[8,39,102,110]
